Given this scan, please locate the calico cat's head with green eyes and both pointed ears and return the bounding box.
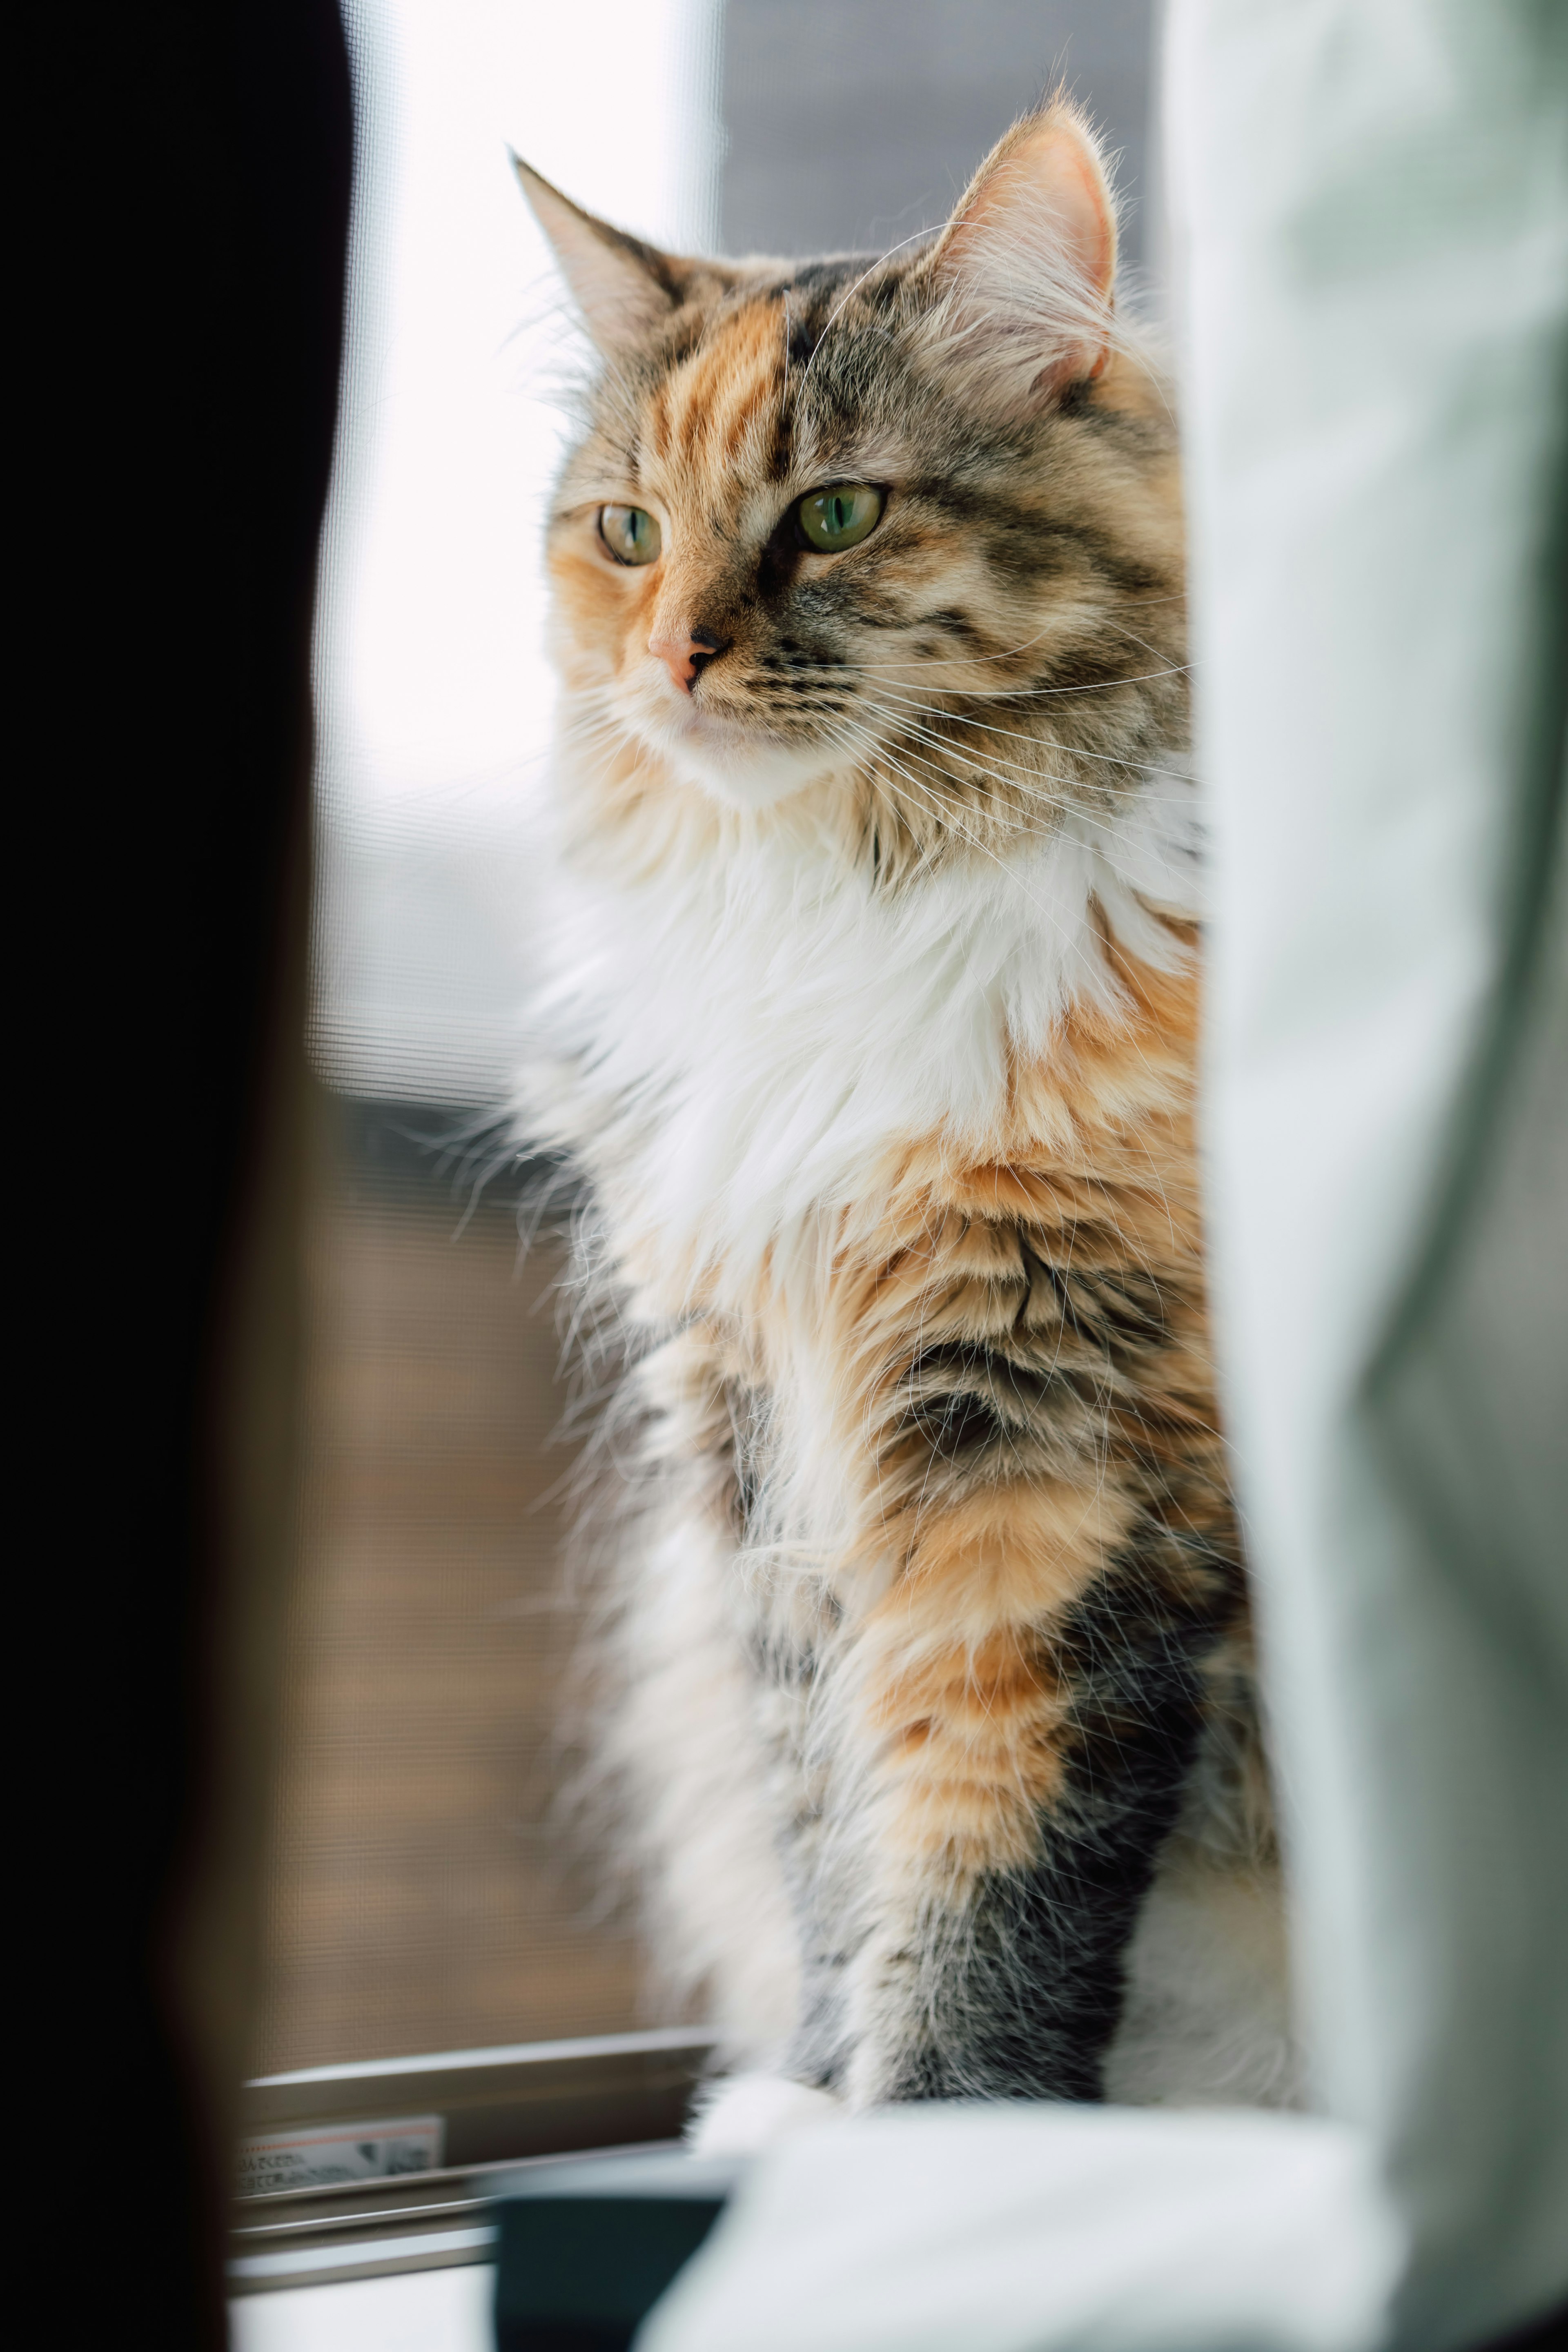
[519,99,1185,882]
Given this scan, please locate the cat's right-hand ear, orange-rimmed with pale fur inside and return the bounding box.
[929,96,1117,419]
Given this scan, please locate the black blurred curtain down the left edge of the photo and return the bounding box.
[29,0,353,2347]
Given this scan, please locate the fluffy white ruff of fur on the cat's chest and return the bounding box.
[524,774,1199,1277]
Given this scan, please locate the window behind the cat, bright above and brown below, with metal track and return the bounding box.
[245,0,1159,2284]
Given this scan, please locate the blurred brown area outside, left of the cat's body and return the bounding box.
[254,1098,663,2074]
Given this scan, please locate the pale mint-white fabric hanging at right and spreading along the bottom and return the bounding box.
[639,13,1568,2352]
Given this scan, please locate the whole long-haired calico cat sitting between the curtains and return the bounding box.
[519,96,1291,2147]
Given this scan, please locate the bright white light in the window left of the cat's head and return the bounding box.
[315,0,719,1103]
